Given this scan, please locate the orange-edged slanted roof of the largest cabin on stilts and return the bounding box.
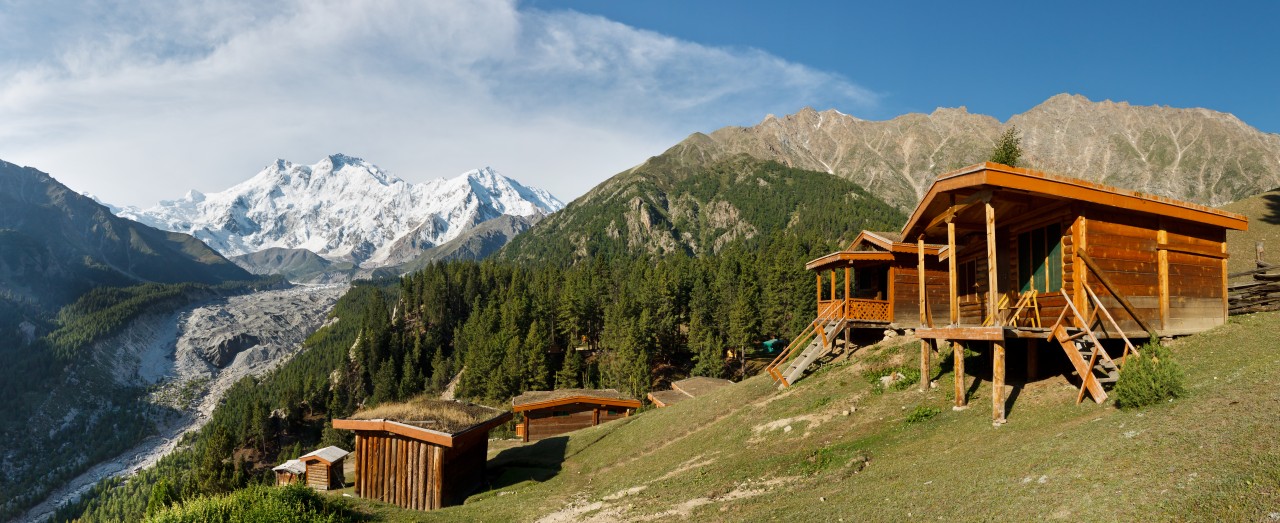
[902,161,1248,238]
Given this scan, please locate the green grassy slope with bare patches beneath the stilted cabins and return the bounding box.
[357,313,1280,520]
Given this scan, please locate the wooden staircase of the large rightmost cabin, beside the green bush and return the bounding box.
[1050,285,1138,403]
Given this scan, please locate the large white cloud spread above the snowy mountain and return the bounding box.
[0,0,876,205]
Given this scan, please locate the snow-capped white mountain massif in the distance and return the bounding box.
[118,155,564,267]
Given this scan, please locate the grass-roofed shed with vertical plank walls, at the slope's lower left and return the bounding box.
[333,398,511,510]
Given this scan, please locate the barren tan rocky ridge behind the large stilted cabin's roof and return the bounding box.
[701,95,1280,210]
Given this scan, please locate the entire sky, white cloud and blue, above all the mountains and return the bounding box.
[0,0,1280,207]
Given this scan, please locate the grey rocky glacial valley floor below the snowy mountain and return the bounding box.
[18,285,347,522]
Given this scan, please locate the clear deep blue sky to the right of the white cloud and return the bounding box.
[529,0,1280,133]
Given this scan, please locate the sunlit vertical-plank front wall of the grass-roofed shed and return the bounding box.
[356,432,445,510]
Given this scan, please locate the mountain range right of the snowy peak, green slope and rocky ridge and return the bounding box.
[498,95,1280,261]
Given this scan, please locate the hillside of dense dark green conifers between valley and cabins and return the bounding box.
[59,159,905,520]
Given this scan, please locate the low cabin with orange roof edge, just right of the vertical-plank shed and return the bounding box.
[511,389,640,441]
